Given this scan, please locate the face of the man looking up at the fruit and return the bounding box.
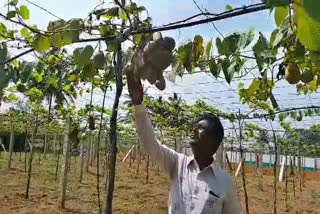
[190,120,219,158]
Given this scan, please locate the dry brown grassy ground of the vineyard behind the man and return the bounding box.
[0,154,320,214]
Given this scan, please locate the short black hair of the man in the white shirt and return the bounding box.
[195,112,224,143]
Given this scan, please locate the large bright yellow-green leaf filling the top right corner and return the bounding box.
[294,0,320,51]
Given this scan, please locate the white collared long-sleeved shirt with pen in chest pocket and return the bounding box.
[135,104,240,214]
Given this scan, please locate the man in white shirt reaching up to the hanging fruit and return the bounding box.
[127,43,240,214]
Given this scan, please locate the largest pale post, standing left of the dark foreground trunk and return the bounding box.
[60,117,71,208]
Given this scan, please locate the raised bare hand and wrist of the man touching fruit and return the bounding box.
[126,70,143,105]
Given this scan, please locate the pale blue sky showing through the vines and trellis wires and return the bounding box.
[0,0,320,132]
